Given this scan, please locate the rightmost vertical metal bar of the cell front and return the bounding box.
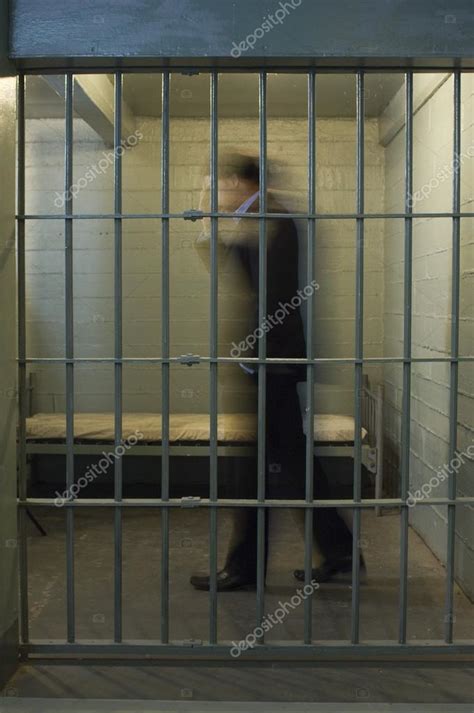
[445,70,461,644]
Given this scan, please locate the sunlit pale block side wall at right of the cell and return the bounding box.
[384,74,474,597]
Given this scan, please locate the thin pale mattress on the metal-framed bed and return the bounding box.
[26,412,367,443]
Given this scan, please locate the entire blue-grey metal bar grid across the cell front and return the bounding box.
[17,62,474,652]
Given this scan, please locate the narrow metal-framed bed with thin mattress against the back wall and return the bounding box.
[26,375,383,497]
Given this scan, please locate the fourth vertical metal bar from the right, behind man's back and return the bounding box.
[304,72,316,644]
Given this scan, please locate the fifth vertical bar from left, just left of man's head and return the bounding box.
[209,72,218,644]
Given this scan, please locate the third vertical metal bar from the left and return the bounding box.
[114,72,123,642]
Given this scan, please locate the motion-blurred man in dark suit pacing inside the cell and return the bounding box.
[191,153,358,591]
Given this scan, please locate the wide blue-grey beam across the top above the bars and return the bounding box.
[11,0,474,61]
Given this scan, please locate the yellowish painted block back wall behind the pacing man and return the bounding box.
[26,112,384,413]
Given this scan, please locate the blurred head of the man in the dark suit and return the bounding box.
[218,152,260,213]
